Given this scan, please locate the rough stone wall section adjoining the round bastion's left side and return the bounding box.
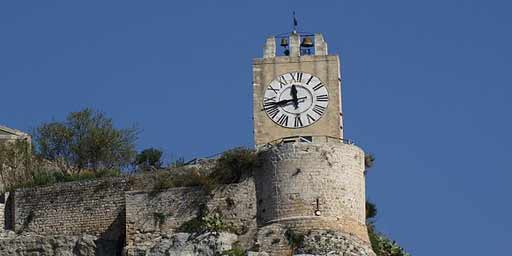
[125,179,257,246]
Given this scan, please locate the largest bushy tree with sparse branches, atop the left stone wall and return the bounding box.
[34,108,137,172]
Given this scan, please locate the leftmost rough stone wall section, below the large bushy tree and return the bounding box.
[14,178,128,240]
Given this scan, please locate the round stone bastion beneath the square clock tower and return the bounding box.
[254,140,369,243]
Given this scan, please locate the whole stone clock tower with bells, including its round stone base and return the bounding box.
[253,32,374,255]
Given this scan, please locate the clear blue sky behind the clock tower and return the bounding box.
[0,0,512,256]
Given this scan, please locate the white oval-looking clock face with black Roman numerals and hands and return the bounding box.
[263,72,329,128]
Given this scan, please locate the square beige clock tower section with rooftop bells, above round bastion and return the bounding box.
[253,32,343,147]
